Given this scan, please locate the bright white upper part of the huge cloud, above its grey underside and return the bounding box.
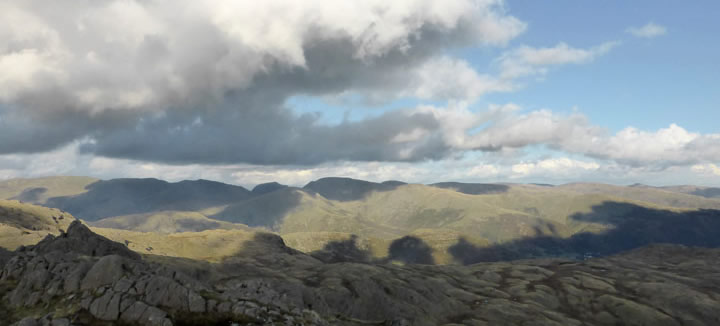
[0,0,525,111]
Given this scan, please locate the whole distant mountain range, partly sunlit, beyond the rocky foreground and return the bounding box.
[0,178,720,264]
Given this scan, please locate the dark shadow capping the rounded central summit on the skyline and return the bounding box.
[303,177,406,201]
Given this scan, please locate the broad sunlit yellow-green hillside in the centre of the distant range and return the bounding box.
[264,185,680,242]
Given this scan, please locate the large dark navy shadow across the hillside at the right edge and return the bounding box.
[448,202,720,265]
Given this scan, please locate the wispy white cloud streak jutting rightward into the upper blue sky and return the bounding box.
[497,42,619,80]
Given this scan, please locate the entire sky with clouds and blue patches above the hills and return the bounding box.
[0,0,720,186]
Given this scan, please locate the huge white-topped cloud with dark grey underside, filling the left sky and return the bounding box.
[0,0,526,164]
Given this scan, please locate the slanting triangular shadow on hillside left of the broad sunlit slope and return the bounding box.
[210,188,302,229]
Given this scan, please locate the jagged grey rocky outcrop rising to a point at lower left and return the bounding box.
[0,223,324,326]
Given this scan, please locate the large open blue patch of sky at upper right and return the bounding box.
[496,0,720,132]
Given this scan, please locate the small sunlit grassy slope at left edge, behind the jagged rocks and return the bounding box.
[0,200,75,250]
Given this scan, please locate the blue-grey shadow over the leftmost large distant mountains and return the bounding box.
[45,179,250,221]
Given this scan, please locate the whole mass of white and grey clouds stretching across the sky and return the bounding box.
[0,0,720,179]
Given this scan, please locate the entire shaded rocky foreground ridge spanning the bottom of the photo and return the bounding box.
[0,222,720,326]
